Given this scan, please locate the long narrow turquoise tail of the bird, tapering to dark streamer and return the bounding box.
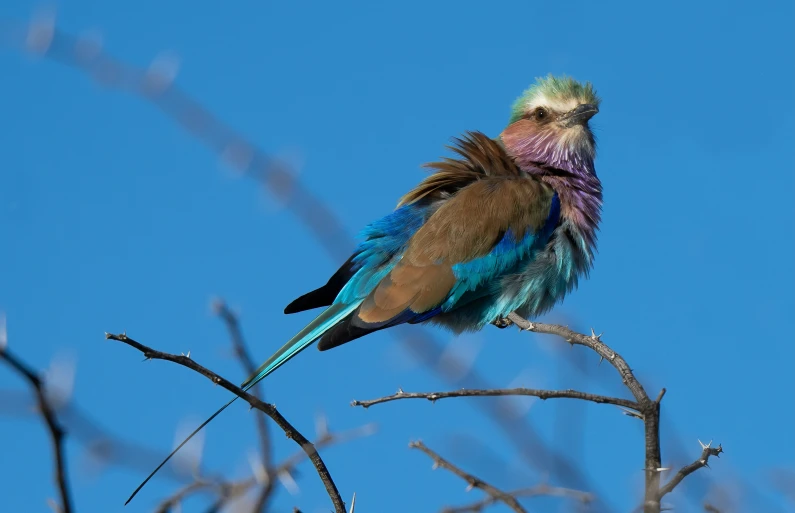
[124,303,359,506]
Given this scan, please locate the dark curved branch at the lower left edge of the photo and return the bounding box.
[0,340,72,513]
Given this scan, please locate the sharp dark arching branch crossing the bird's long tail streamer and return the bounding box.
[105,333,345,513]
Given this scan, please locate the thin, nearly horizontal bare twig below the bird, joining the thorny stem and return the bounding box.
[351,388,639,410]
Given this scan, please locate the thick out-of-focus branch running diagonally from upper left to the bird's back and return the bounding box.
[3,16,350,259]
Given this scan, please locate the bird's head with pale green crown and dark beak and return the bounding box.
[500,75,600,172]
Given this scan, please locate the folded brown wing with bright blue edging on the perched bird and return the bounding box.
[318,176,559,350]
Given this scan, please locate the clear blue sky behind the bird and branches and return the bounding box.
[0,0,795,513]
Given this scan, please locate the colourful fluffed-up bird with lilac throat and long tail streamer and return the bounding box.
[127,75,602,503]
